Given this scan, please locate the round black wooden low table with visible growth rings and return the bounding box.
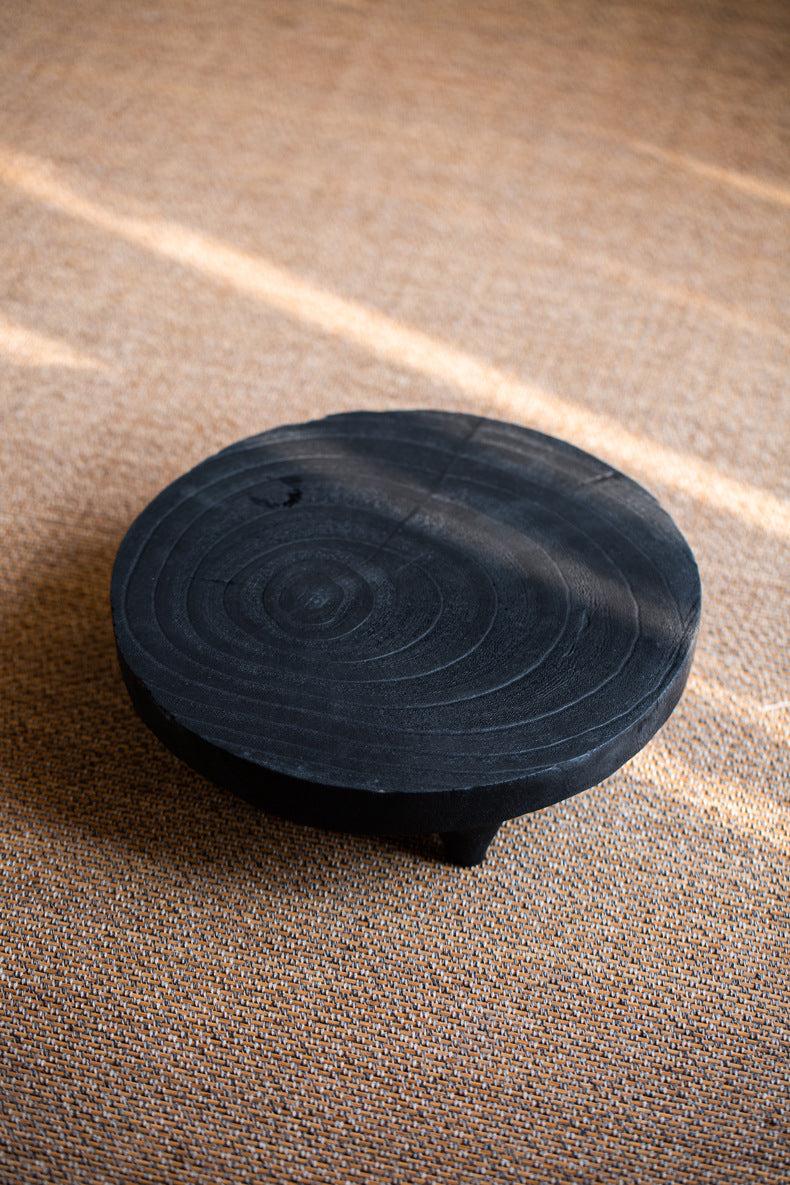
[113,411,700,864]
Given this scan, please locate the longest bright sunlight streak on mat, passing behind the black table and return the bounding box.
[0,148,790,539]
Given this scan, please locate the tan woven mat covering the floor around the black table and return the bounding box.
[0,0,790,1185]
